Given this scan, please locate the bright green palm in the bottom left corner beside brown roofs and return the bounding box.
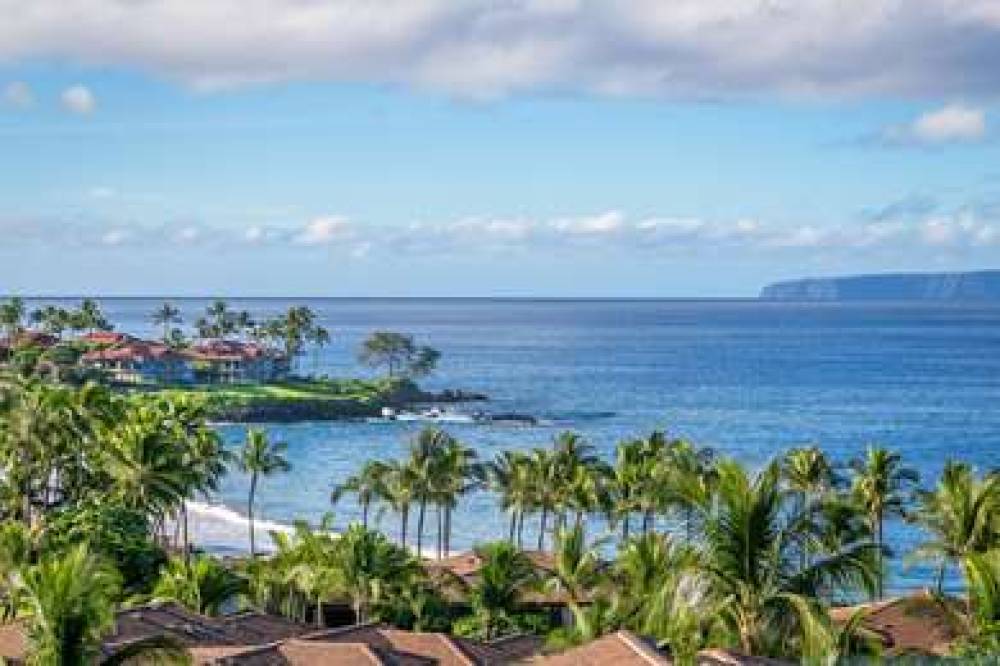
[16,544,120,666]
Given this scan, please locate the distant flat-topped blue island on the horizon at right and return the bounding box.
[760,270,1000,301]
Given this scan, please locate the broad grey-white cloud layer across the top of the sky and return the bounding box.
[0,0,1000,99]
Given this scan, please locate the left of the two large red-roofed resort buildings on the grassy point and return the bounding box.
[80,341,194,385]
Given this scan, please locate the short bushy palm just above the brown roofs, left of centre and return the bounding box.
[152,555,247,615]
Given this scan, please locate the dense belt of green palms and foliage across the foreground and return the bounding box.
[0,376,1000,664]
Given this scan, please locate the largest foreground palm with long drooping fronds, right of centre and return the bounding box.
[699,460,875,655]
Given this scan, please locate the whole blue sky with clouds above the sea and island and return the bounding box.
[0,0,1000,297]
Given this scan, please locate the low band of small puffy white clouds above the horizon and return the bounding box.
[0,209,1000,260]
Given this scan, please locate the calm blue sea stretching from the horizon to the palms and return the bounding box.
[25,299,1000,587]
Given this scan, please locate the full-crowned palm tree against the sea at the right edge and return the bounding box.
[910,462,1000,592]
